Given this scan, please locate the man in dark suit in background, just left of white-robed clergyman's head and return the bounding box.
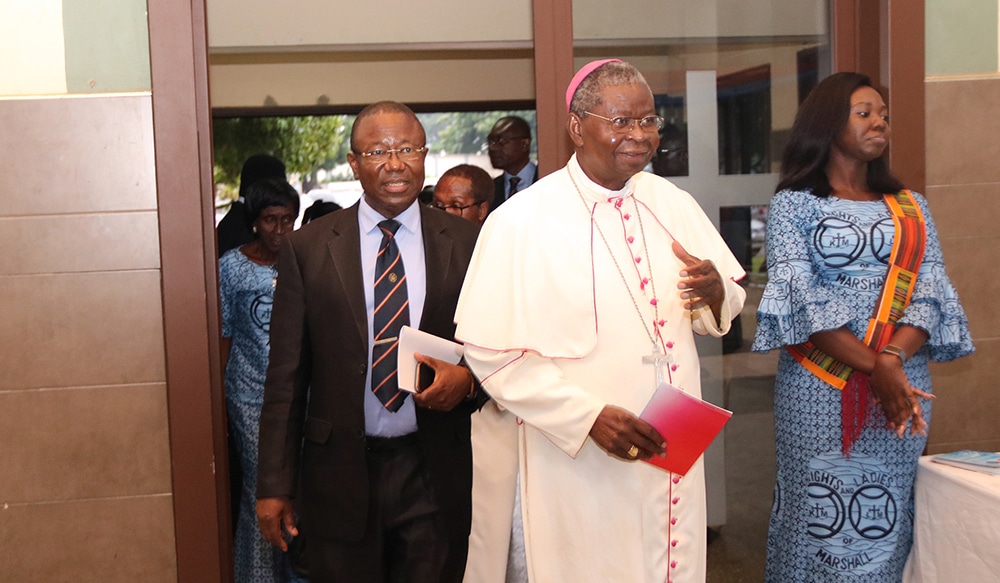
[486,115,538,211]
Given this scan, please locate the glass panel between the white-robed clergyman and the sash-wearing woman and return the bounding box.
[573,0,831,560]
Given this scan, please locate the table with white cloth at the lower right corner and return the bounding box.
[903,456,1000,583]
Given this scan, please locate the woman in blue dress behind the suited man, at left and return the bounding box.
[219,179,299,583]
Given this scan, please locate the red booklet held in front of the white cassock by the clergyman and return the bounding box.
[639,383,733,476]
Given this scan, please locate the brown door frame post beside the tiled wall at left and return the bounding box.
[147,0,232,583]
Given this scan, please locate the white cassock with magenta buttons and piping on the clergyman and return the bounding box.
[456,156,746,583]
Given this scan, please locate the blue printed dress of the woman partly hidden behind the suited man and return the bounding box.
[219,249,304,583]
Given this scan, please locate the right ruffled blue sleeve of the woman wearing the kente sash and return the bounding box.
[898,193,975,362]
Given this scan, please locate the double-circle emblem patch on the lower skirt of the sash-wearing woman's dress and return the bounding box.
[807,452,900,575]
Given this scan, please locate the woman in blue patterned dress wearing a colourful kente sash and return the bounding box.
[753,73,973,583]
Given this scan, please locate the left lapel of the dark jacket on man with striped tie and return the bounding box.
[327,204,368,344]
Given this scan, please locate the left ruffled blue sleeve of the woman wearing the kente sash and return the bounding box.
[752,190,854,352]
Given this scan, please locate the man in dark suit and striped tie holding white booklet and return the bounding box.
[257,102,478,583]
